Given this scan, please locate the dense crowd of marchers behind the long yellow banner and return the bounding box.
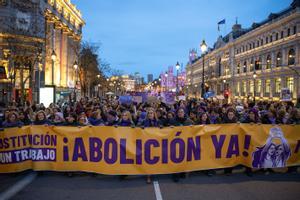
[0,97,300,183]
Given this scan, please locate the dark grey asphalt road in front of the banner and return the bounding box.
[0,172,300,200]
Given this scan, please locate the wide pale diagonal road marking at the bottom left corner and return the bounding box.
[0,172,37,200]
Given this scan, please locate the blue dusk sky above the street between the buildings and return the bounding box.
[72,0,292,77]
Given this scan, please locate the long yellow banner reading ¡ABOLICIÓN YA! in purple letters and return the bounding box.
[0,124,300,175]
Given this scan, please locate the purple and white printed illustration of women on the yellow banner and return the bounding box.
[252,127,291,168]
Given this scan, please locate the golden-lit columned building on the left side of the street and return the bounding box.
[0,0,84,102]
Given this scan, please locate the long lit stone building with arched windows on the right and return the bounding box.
[186,0,300,101]
